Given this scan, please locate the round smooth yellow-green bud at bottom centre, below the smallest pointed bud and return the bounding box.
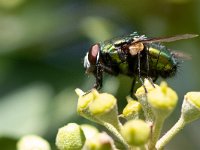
[121,120,150,146]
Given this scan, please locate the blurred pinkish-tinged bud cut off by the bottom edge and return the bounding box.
[84,133,114,150]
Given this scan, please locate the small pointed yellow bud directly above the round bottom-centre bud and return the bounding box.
[122,97,143,120]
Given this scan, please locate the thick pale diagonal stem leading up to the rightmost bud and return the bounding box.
[156,117,186,150]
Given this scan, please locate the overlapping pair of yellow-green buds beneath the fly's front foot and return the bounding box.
[76,89,120,132]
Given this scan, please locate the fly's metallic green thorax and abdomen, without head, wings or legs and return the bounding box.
[100,32,177,78]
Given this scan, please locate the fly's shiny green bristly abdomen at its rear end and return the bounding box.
[148,44,177,78]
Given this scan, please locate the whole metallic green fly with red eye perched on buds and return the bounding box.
[84,32,198,92]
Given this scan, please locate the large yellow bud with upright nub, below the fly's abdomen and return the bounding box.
[147,82,178,115]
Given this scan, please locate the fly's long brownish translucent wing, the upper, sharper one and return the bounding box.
[133,34,199,44]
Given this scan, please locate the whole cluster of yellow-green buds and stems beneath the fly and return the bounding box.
[56,79,200,150]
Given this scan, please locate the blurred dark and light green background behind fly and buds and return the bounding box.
[0,0,200,150]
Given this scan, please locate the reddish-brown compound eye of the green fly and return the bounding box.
[88,44,100,65]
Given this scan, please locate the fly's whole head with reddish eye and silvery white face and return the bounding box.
[84,44,100,74]
